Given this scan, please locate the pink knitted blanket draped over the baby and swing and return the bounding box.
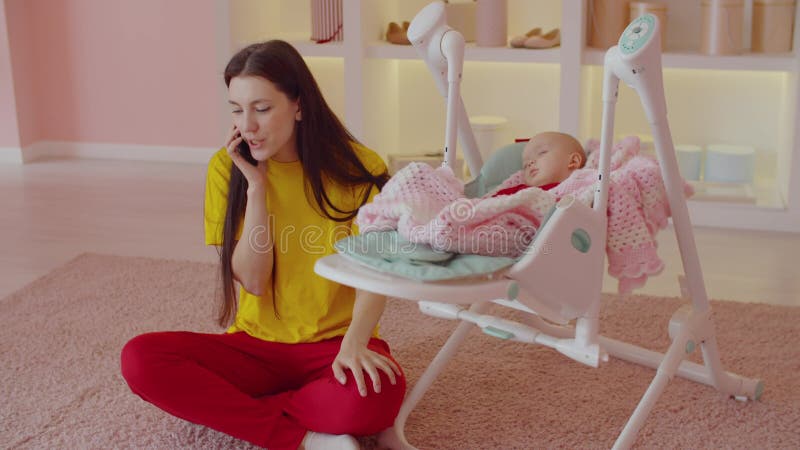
[356,137,692,293]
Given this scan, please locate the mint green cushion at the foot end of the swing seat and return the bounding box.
[334,230,515,281]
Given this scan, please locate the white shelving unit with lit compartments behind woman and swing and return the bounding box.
[218,0,800,231]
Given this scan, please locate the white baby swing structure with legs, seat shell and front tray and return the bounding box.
[315,2,764,449]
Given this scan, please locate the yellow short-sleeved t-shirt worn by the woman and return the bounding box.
[204,144,386,343]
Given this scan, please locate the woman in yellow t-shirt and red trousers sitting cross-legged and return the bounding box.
[122,41,405,450]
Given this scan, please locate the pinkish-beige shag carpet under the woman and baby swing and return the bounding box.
[0,254,800,449]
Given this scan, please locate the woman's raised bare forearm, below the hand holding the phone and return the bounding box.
[232,175,274,295]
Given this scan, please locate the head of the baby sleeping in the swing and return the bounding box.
[522,131,586,186]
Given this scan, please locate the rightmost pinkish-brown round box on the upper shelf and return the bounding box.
[752,0,795,53]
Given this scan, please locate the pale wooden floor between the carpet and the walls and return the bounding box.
[0,160,800,305]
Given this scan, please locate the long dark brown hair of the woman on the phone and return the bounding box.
[217,40,389,326]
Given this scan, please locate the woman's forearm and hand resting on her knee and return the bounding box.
[332,290,402,397]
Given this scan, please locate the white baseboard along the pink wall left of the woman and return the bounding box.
[13,141,219,164]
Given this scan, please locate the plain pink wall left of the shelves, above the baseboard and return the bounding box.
[5,0,222,147]
